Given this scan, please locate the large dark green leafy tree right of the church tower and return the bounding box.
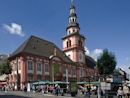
[97,49,117,75]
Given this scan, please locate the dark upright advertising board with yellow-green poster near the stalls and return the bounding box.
[70,78,77,93]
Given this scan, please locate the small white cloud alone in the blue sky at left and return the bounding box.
[3,23,24,36]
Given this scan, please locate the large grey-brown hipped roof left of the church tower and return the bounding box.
[10,36,74,64]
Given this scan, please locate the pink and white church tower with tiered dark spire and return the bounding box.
[62,2,85,64]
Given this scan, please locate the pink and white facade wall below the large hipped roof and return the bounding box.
[9,54,86,89]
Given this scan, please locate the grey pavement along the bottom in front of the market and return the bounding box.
[0,91,117,98]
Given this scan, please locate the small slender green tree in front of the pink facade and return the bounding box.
[50,63,61,80]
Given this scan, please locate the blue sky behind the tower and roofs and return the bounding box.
[0,0,130,72]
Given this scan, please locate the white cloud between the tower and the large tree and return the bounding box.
[85,47,103,61]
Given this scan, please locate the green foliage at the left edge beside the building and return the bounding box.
[0,60,12,75]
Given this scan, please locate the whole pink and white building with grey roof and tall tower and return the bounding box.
[9,5,98,89]
